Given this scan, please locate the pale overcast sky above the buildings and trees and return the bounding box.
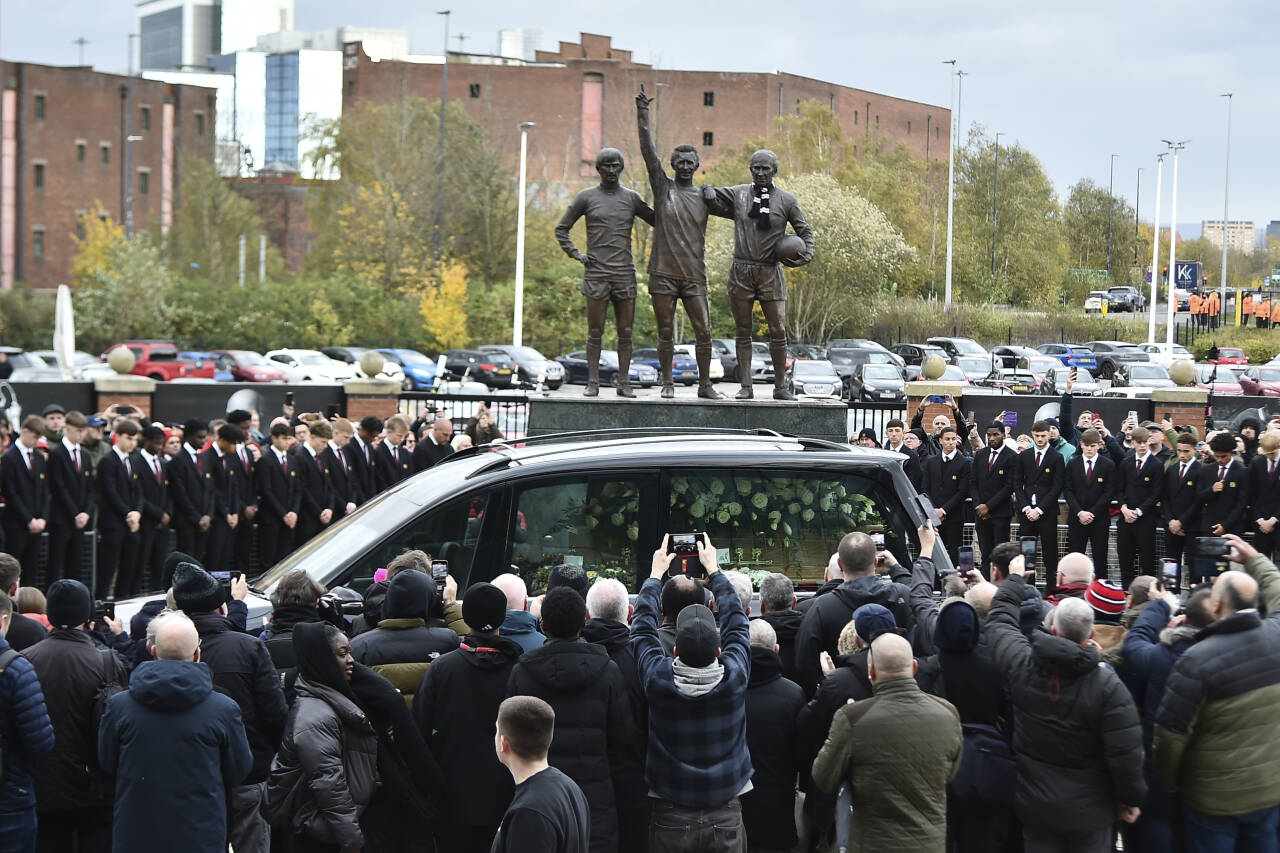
[10,0,1280,239]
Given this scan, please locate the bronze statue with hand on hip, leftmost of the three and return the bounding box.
[556,149,654,397]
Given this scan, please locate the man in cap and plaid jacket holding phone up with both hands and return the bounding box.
[631,534,751,853]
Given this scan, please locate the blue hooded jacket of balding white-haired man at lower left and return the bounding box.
[97,661,253,853]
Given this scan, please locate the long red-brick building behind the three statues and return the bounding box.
[343,33,951,183]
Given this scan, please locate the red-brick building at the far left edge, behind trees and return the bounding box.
[0,61,215,289]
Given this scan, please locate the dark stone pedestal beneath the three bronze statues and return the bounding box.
[527,397,849,444]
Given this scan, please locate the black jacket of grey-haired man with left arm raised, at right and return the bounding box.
[987,575,1147,833]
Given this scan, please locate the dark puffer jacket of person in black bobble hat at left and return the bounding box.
[191,613,288,785]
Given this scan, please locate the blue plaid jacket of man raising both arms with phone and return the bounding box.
[631,573,751,808]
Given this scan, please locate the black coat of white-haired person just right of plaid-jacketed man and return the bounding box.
[742,646,804,850]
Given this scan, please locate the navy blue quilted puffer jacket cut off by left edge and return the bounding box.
[0,637,54,811]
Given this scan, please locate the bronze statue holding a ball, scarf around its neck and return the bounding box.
[703,150,813,400]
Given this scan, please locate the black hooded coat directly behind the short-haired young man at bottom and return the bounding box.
[507,638,636,853]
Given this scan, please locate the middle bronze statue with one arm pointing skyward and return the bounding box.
[636,86,721,400]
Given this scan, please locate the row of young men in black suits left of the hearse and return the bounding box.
[0,403,503,599]
